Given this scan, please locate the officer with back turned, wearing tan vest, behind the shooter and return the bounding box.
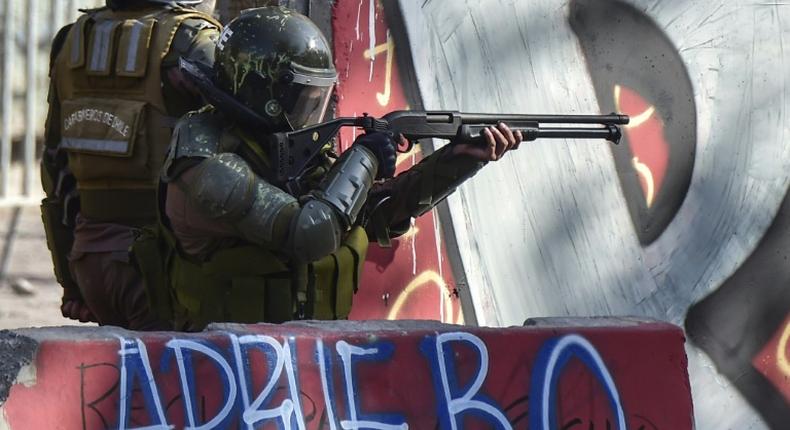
[41,0,220,330]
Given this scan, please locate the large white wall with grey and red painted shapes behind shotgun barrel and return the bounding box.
[398,0,790,429]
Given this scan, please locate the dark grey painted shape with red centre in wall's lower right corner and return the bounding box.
[685,192,790,428]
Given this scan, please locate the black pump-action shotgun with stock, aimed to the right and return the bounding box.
[270,110,629,191]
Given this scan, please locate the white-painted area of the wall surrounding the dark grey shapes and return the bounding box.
[400,0,790,429]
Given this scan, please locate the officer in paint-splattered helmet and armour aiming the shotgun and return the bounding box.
[149,7,521,330]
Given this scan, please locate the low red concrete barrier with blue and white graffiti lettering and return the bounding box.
[0,319,692,430]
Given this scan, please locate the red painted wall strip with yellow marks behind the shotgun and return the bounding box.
[333,0,463,323]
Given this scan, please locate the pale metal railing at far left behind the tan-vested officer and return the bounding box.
[0,0,104,206]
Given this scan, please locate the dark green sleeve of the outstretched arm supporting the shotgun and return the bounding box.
[364,145,485,247]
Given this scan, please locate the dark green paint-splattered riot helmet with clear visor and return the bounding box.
[213,7,337,132]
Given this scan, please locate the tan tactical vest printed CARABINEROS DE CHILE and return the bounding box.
[55,8,220,225]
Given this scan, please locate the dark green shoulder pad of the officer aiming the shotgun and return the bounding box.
[162,110,222,182]
